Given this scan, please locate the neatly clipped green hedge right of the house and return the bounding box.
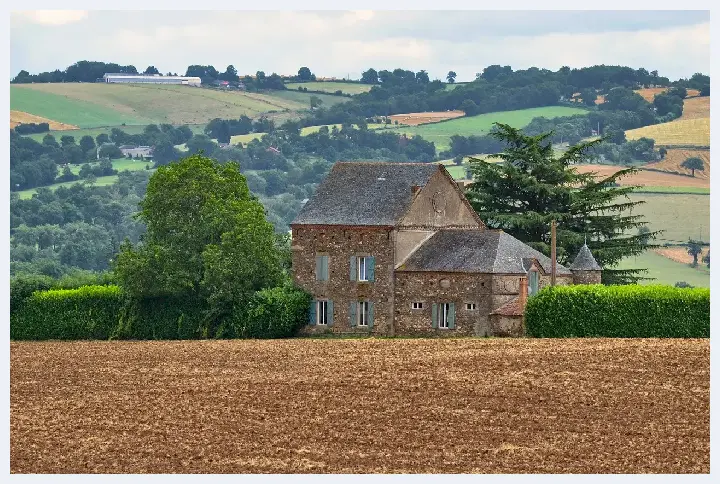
[525,285,710,338]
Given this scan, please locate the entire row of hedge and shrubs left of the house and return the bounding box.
[10,280,311,340]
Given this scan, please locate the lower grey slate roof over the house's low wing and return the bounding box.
[398,230,572,275]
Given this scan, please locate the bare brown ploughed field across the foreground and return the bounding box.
[10,339,710,473]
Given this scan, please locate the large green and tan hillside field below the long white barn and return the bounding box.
[10,83,320,128]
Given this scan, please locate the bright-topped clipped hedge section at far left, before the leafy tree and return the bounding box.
[10,286,123,340]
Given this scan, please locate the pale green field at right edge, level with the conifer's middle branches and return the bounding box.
[630,193,710,244]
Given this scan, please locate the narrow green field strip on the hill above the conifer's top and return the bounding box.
[380,106,587,153]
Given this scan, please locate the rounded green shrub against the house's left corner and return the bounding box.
[228,286,312,338]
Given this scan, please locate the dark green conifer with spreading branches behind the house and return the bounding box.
[467,123,658,284]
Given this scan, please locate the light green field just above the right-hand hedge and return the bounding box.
[615,251,710,287]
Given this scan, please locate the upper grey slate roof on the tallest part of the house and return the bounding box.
[291,161,440,226]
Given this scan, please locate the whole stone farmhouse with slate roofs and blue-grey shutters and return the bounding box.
[291,162,601,336]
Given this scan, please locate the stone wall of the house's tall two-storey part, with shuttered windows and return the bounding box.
[292,226,395,334]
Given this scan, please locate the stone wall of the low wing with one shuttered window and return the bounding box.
[395,271,492,336]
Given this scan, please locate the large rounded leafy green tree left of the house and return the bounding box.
[115,155,282,326]
